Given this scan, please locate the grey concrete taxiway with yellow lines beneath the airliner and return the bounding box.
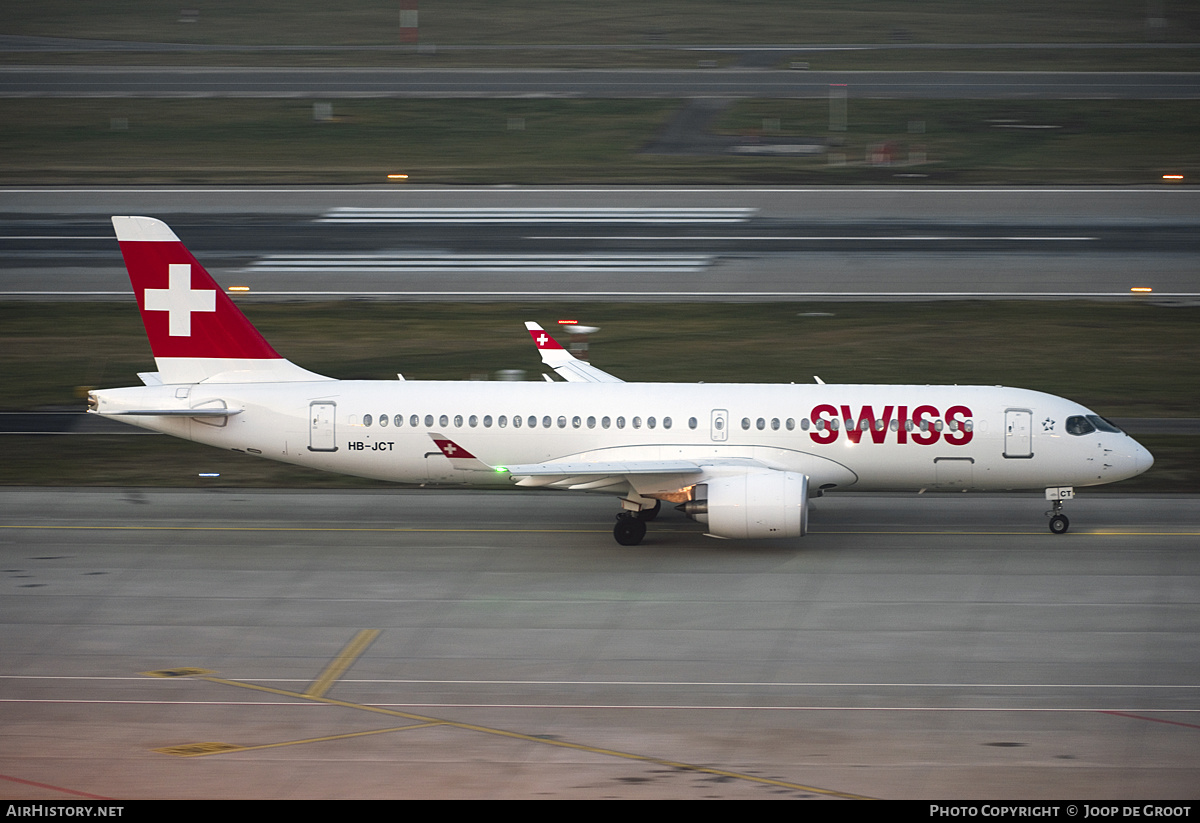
[0,489,1200,800]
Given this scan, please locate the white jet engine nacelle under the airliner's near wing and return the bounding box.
[682,471,809,539]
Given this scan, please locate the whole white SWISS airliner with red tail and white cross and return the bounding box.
[88,217,1153,546]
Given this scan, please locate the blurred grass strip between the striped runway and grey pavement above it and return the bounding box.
[0,100,1200,185]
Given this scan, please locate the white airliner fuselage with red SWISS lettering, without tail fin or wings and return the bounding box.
[95,380,1153,493]
